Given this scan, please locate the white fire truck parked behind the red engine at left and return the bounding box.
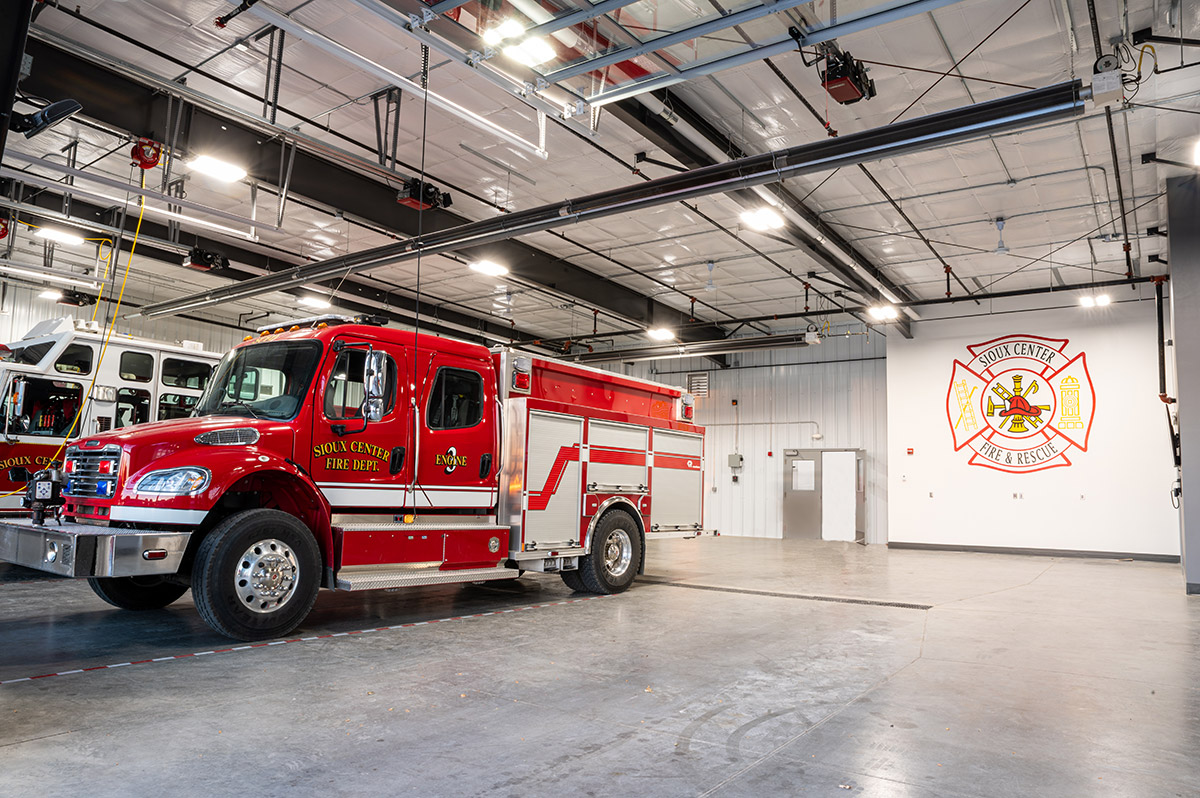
[0,318,221,509]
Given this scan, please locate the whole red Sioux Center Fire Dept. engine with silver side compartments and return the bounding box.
[0,317,704,641]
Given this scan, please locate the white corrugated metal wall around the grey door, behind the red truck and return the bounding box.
[608,324,888,542]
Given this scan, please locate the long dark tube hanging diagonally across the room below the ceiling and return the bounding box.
[129,79,1090,316]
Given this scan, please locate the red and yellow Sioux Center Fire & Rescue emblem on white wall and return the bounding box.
[946,335,1096,474]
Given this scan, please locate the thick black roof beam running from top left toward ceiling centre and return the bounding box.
[18,40,724,340]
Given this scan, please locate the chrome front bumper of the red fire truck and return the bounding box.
[0,518,192,577]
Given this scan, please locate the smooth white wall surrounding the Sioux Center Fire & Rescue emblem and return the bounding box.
[887,290,1180,554]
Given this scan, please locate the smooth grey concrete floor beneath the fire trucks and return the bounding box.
[0,538,1200,798]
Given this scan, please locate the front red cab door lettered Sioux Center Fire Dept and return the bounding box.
[308,336,412,512]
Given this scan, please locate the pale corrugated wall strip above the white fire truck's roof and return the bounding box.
[0,283,245,353]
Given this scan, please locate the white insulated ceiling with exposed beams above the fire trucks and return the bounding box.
[4,0,1200,349]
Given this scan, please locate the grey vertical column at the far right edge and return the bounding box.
[1166,174,1200,593]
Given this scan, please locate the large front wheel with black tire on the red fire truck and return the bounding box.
[192,510,320,642]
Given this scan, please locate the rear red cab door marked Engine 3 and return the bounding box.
[416,353,499,509]
